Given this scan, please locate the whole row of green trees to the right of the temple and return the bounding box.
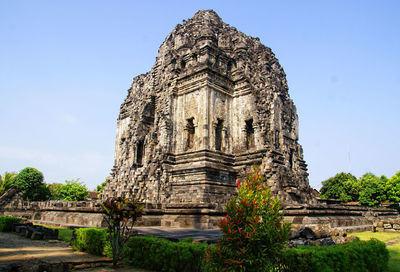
[320,171,400,206]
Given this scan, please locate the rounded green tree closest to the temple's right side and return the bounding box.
[320,172,360,202]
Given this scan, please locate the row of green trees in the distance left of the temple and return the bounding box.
[0,167,88,201]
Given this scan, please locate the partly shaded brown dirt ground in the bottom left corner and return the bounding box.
[0,232,146,272]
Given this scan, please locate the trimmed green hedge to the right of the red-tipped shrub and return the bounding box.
[277,239,389,272]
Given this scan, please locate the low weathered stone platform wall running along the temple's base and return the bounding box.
[0,195,400,232]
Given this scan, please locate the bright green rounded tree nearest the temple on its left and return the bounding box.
[53,179,89,201]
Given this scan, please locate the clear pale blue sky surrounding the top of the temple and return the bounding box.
[0,0,400,189]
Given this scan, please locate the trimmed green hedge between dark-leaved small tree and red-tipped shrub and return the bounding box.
[123,236,207,272]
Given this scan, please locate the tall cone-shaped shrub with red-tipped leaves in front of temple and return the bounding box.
[206,167,290,271]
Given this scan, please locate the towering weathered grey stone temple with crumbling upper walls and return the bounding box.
[103,10,315,224]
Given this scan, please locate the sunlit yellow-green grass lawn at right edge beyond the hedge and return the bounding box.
[349,231,400,272]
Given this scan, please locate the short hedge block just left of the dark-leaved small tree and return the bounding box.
[71,228,107,255]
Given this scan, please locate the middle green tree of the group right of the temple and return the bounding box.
[358,173,386,206]
